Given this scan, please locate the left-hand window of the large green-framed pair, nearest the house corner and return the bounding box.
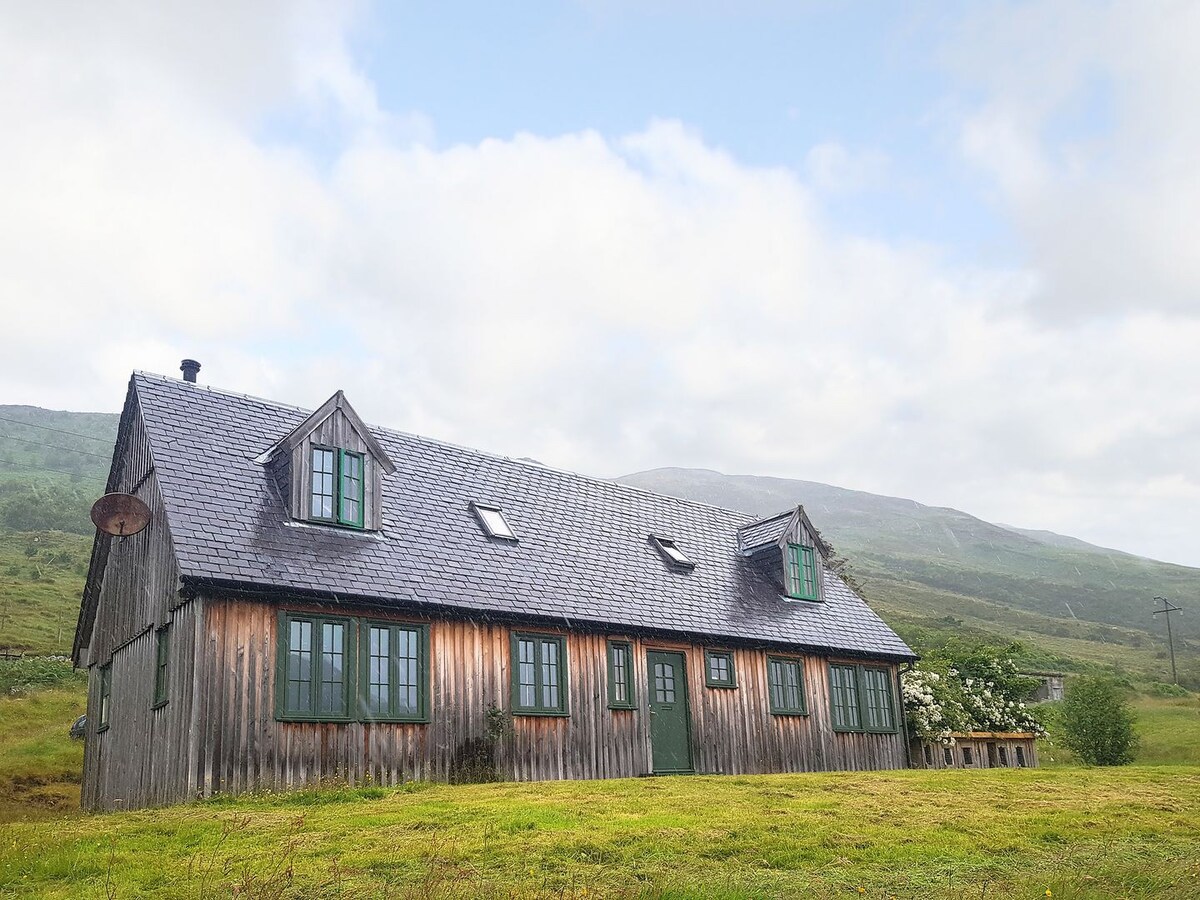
[275,612,358,722]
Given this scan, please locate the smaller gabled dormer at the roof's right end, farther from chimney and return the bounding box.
[738,506,830,602]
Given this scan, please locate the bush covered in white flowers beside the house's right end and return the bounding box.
[901,649,1045,744]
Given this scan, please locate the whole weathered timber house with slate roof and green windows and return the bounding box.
[74,367,913,810]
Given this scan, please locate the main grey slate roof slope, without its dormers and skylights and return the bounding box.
[131,373,913,659]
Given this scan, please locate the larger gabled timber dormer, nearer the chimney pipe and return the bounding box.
[259,391,396,530]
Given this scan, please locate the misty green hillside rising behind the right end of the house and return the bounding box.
[617,468,1200,677]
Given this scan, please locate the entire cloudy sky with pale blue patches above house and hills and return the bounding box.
[0,0,1200,565]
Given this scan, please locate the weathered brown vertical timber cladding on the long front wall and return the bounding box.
[190,599,906,794]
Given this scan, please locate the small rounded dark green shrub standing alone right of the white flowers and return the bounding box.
[1060,676,1138,766]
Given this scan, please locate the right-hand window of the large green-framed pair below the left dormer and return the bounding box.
[359,619,430,722]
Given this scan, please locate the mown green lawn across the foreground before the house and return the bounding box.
[0,767,1200,898]
